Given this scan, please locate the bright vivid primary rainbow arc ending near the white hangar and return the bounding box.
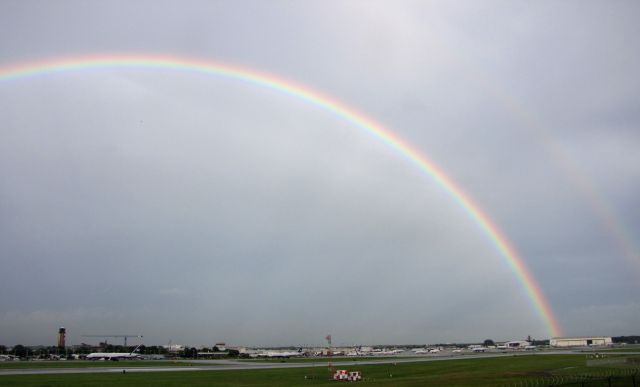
[0,55,561,336]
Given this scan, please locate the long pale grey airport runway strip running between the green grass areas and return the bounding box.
[0,351,576,376]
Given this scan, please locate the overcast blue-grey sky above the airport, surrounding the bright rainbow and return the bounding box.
[0,1,640,346]
